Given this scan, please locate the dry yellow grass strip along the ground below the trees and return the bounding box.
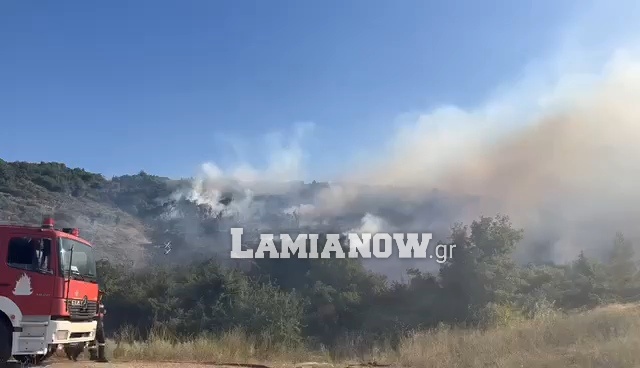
[105,305,640,368]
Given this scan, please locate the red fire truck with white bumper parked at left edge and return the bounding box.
[0,217,98,365]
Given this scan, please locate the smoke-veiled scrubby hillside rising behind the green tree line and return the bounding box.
[0,160,476,278]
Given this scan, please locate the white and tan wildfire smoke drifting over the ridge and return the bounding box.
[165,3,640,274]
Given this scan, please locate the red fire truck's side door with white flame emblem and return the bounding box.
[0,231,55,316]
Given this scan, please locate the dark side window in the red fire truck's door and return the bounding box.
[7,237,53,273]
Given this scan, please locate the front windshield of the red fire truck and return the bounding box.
[58,238,96,281]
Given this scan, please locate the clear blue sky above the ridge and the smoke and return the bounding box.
[0,0,578,178]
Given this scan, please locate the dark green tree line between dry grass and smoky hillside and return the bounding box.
[99,215,640,346]
